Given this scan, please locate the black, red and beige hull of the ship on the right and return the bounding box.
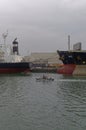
[57,51,86,76]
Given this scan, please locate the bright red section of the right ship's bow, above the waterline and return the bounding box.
[57,64,76,74]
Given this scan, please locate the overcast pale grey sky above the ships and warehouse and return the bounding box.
[0,0,86,55]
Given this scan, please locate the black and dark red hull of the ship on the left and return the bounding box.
[0,62,30,74]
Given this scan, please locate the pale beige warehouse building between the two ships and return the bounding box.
[25,52,62,67]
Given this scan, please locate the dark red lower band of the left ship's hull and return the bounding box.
[0,68,30,74]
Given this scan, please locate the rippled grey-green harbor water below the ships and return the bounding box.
[0,73,86,130]
